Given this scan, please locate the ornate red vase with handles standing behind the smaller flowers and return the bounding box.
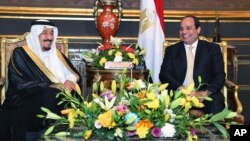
[94,0,122,45]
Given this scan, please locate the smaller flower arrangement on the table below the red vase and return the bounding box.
[82,36,145,69]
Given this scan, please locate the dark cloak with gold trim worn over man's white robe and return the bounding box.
[3,46,81,131]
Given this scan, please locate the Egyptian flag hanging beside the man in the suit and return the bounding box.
[138,0,165,82]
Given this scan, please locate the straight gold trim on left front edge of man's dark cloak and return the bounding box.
[22,45,57,83]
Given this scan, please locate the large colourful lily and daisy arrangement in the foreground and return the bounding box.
[38,70,236,141]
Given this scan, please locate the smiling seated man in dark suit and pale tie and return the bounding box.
[159,16,225,114]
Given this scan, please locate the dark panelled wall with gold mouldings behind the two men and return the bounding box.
[0,0,250,124]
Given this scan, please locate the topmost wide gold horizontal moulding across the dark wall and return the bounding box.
[0,6,250,19]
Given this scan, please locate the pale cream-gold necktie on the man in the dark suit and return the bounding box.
[186,45,194,85]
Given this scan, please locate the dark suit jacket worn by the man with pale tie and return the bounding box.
[159,40,225,93]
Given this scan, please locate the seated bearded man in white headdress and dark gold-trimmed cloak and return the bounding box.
[2,20,81,140]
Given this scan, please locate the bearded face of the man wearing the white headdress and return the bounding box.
[39,26,54,51]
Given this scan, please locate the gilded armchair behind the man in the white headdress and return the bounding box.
[0,32,68,103]
